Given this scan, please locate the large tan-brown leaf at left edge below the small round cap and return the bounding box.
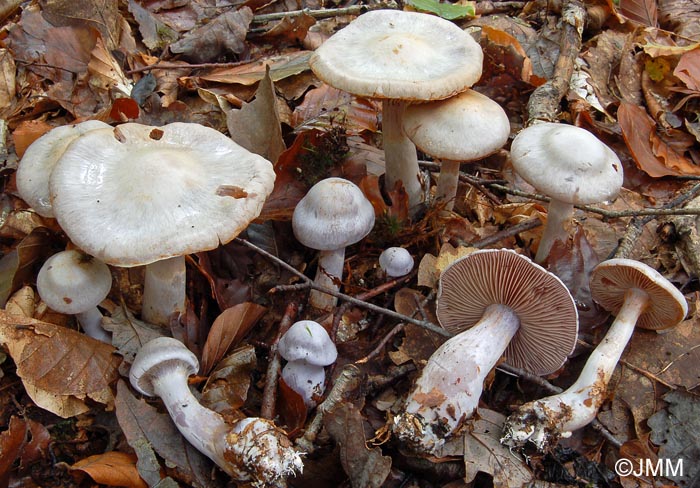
[0,310,121,418]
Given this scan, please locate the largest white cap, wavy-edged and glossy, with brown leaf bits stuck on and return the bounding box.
[50,123,275,266]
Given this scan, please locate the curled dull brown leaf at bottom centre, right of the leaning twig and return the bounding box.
[323,403,391,488]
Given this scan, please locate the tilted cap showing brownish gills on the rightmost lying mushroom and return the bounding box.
[590,258,688,329]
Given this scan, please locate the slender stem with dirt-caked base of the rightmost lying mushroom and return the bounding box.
[502,288,649,451]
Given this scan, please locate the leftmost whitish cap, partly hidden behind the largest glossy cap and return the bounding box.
[15,120,109,217]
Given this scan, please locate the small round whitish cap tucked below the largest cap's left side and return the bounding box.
[36,249,112,315]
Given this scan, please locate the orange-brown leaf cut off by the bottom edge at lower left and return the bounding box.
[69,451,148,488]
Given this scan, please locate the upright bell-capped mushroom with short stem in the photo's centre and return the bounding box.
[292,178,374,311]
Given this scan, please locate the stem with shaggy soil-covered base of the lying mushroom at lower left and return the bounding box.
[152,356,302,478]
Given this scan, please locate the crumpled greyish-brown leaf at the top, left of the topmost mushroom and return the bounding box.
[170,7,253,63]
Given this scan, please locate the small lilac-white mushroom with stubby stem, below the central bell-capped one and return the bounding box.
[277,320,338,407]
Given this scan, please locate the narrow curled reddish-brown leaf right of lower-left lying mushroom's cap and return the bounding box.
[201,302,267,375]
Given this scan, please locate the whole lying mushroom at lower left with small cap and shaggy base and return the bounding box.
[129,337,303,486]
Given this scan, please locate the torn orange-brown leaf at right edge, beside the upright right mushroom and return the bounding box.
[617,102,700,178]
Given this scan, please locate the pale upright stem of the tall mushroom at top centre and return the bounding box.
[382,99,423,212]
